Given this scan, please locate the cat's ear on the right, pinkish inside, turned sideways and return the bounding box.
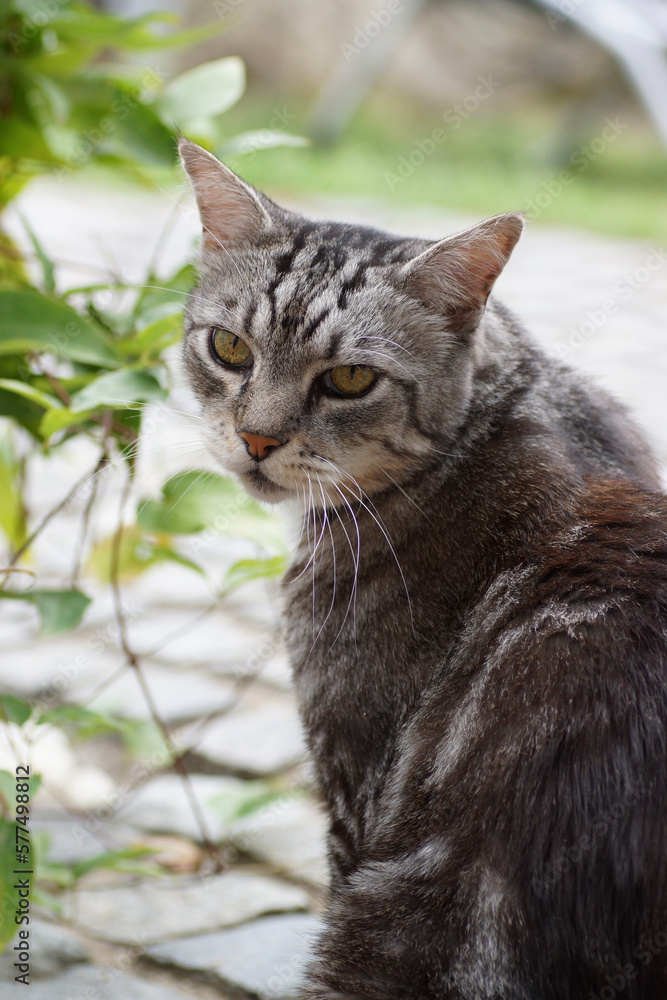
[403,212,524,333]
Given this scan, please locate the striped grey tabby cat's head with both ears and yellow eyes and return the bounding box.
[180,140,523,506]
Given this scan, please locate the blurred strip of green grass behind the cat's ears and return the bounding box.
[219,96,667,239]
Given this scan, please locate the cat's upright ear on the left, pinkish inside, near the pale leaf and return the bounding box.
[178,139,271,250]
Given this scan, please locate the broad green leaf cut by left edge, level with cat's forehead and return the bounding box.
[0,291,119,368]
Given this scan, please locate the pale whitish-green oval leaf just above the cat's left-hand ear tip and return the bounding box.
[156,56,245,127]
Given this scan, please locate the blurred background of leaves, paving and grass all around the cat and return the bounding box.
[0,0,667,1000]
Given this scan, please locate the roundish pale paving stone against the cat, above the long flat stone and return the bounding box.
[230,793,329,888]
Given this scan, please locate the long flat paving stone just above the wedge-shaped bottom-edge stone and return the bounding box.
[65,871,307,947]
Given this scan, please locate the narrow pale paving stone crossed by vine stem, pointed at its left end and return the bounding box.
[86,664,234,722]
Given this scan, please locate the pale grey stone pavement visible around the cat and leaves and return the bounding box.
[0,176,667,1000]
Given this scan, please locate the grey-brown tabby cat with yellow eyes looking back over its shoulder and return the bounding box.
[180,140,667,1000]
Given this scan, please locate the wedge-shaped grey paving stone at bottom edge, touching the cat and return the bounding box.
[146,913,323,1000]
